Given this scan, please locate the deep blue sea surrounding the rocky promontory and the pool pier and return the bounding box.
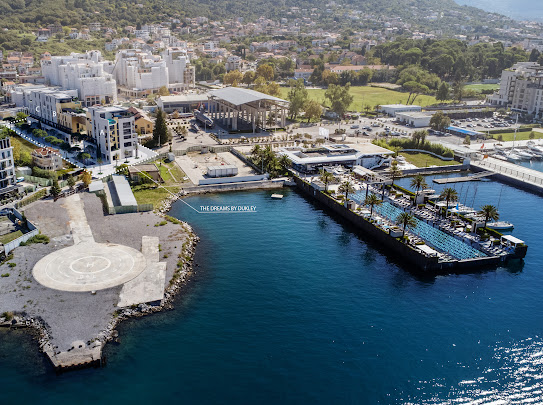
[0,180,543,404]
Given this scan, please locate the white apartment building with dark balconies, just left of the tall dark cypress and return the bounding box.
[87,107,138,163]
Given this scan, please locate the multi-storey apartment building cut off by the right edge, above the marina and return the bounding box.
[487,62,543,118]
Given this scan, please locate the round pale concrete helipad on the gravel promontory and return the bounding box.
[33,242,146,292]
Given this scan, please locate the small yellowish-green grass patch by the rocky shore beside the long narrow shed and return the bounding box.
[132,161,185,209]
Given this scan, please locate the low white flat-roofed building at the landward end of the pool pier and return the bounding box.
[278,143,394,173]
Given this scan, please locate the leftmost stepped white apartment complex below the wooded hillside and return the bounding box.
[41,51,117,106]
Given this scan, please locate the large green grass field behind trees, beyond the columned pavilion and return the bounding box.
[281,86,437,111]
